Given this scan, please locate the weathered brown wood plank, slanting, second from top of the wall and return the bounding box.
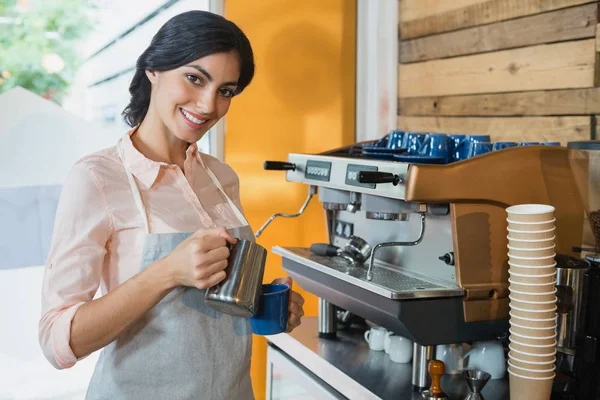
[399,3,598,63]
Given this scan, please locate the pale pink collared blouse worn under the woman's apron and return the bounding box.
[39,130,242,368]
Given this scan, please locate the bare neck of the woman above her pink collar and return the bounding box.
[131,109,190,170]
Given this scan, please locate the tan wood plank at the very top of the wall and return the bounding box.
[399,0,591,39]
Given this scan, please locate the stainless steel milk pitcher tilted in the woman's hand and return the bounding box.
[204,239,267,318]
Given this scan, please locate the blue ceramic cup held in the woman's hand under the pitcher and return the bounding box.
[250,283,290,336]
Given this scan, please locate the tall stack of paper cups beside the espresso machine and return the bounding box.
[506,204,556,400]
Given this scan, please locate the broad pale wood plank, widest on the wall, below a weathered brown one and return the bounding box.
[398,39,596,97]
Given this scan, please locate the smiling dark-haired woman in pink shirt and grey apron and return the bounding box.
[40,11,304,400]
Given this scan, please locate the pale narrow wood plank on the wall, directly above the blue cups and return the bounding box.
[398,115,592,144]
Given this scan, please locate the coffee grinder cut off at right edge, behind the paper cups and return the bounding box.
[552,141,600,400]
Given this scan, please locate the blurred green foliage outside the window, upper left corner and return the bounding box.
[0,0,96,104]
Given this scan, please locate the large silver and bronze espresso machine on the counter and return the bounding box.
[261,143,584,389]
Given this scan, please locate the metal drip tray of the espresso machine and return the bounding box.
[273,246,464,300]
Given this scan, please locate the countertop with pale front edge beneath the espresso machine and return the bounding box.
[267,317,509,400]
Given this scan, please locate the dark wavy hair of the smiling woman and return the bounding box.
[123,11,254,127]
